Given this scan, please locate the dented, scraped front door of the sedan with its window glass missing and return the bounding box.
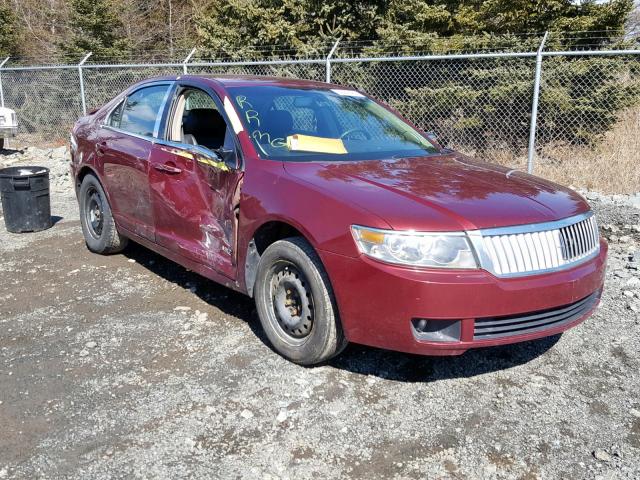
[149,88,242,278]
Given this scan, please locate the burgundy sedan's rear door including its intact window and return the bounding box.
[96,82,172,240]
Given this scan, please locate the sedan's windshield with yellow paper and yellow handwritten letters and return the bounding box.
[228,86,438,161]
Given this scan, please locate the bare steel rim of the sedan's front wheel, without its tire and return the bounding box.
[267,261,315,345]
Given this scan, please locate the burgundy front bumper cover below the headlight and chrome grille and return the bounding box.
[320,240,607,355]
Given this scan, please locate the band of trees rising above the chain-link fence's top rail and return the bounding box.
[0,0,638,62]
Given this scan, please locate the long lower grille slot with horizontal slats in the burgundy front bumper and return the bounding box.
[473,292,600,340]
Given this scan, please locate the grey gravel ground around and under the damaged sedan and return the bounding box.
[0,150,640,479]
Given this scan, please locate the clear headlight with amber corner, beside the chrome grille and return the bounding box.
[351,225,478,268]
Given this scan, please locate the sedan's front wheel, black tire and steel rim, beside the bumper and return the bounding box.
[255,237,347,365]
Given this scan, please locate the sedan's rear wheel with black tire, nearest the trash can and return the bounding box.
[78,174,128,255]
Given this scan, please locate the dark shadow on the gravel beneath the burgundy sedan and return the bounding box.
[123,243,561,382]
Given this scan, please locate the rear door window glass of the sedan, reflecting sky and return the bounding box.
[120,85,170,137]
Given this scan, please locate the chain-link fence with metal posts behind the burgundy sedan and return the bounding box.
[0,44,640,173]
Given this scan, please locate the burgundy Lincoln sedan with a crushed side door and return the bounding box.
[71,76,607,365]
